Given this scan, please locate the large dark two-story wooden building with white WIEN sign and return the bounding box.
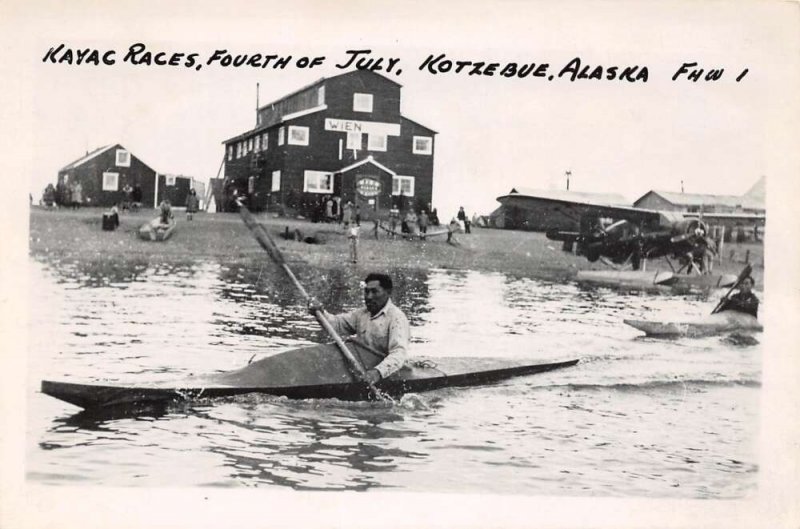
[223,70,436,216]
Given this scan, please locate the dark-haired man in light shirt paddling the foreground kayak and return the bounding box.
[308,273,409,384]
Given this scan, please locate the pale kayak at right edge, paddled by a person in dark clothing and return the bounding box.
[624,310,764,337]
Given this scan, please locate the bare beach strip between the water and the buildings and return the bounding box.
[29,206,764,290]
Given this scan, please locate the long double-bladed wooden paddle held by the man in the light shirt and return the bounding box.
[237,201,384,400]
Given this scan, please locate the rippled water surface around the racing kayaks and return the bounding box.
[27,257,762,498]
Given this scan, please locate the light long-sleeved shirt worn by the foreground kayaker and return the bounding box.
[326,299,409,378]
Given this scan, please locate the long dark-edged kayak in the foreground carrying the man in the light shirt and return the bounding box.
[41,342,578,409]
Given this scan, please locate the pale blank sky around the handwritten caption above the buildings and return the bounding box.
[7,1,791,219]
